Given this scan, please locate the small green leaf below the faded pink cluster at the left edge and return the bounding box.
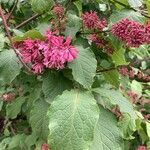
[6,97,25,119]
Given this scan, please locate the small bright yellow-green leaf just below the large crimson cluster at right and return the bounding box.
[112,49,128,66]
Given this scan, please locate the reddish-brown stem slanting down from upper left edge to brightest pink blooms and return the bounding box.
[0,5,32,73]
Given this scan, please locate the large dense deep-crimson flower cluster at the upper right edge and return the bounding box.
[112,18,150,47]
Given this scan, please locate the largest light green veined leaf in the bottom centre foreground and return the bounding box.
[48,90,99,150]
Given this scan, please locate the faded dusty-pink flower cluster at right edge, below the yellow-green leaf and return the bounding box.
[119,66,150,82]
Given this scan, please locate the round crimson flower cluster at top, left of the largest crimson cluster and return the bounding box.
[82,11,107,30]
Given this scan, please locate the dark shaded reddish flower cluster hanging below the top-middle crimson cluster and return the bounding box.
[90,34,114,55]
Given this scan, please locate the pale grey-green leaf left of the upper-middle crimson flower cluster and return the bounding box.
[65,13,82,38]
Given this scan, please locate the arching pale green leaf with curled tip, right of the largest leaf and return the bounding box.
[94,88,138,139]
